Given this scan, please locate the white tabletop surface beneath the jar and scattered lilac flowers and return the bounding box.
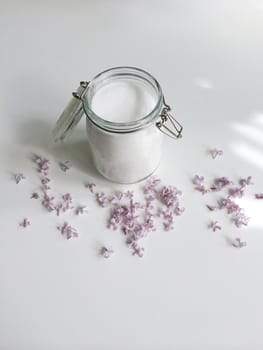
[0,0,263,350]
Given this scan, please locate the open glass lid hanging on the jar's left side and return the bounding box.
[53,81,89,142]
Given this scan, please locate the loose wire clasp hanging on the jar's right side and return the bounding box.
[155,102,183,139]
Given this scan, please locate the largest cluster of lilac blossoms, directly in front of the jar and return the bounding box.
[96,177,184,257]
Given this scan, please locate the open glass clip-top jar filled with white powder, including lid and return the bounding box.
[53,67,182,183]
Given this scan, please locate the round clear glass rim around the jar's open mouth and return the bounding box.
[82,66,164,133]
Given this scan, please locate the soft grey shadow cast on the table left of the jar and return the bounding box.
[17,118,103,179]
